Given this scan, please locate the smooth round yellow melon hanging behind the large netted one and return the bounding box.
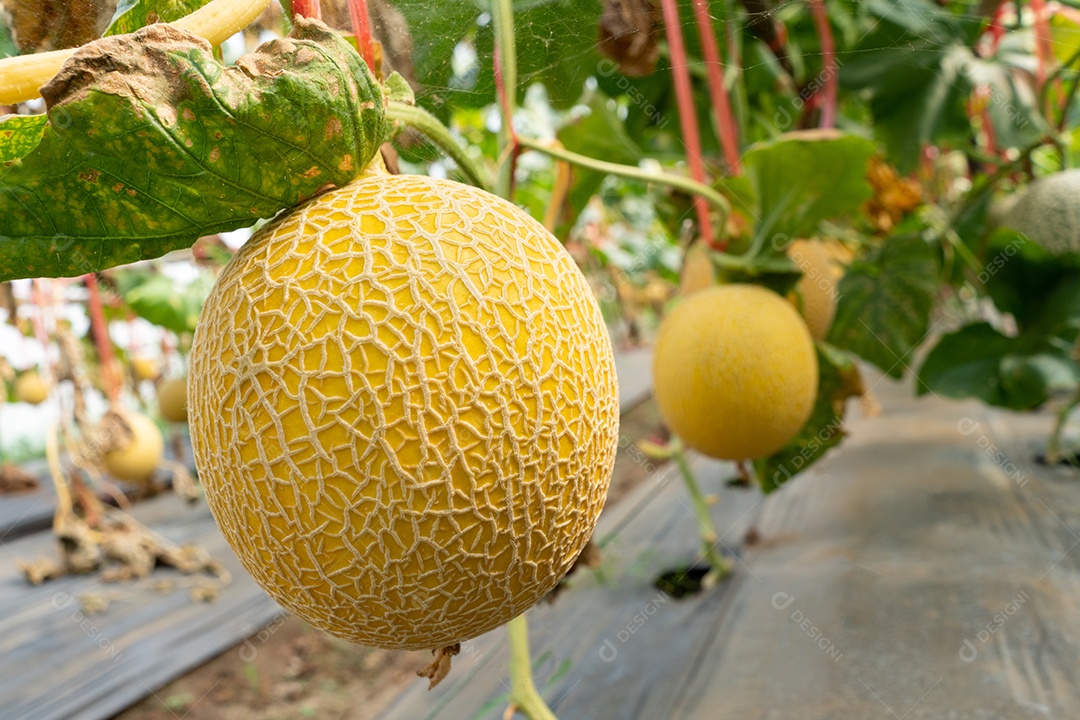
[652,284,818,460]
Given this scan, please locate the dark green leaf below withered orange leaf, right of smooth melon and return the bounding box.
[828,235,940,378]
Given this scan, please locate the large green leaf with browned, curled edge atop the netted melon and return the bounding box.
[0,21,386,281]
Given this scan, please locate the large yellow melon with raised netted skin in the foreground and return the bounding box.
[189,172,619,649]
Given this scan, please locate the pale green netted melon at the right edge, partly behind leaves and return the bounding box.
[989,169,1080,255]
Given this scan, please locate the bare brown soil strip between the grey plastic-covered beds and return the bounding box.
[117,399,664,720]
